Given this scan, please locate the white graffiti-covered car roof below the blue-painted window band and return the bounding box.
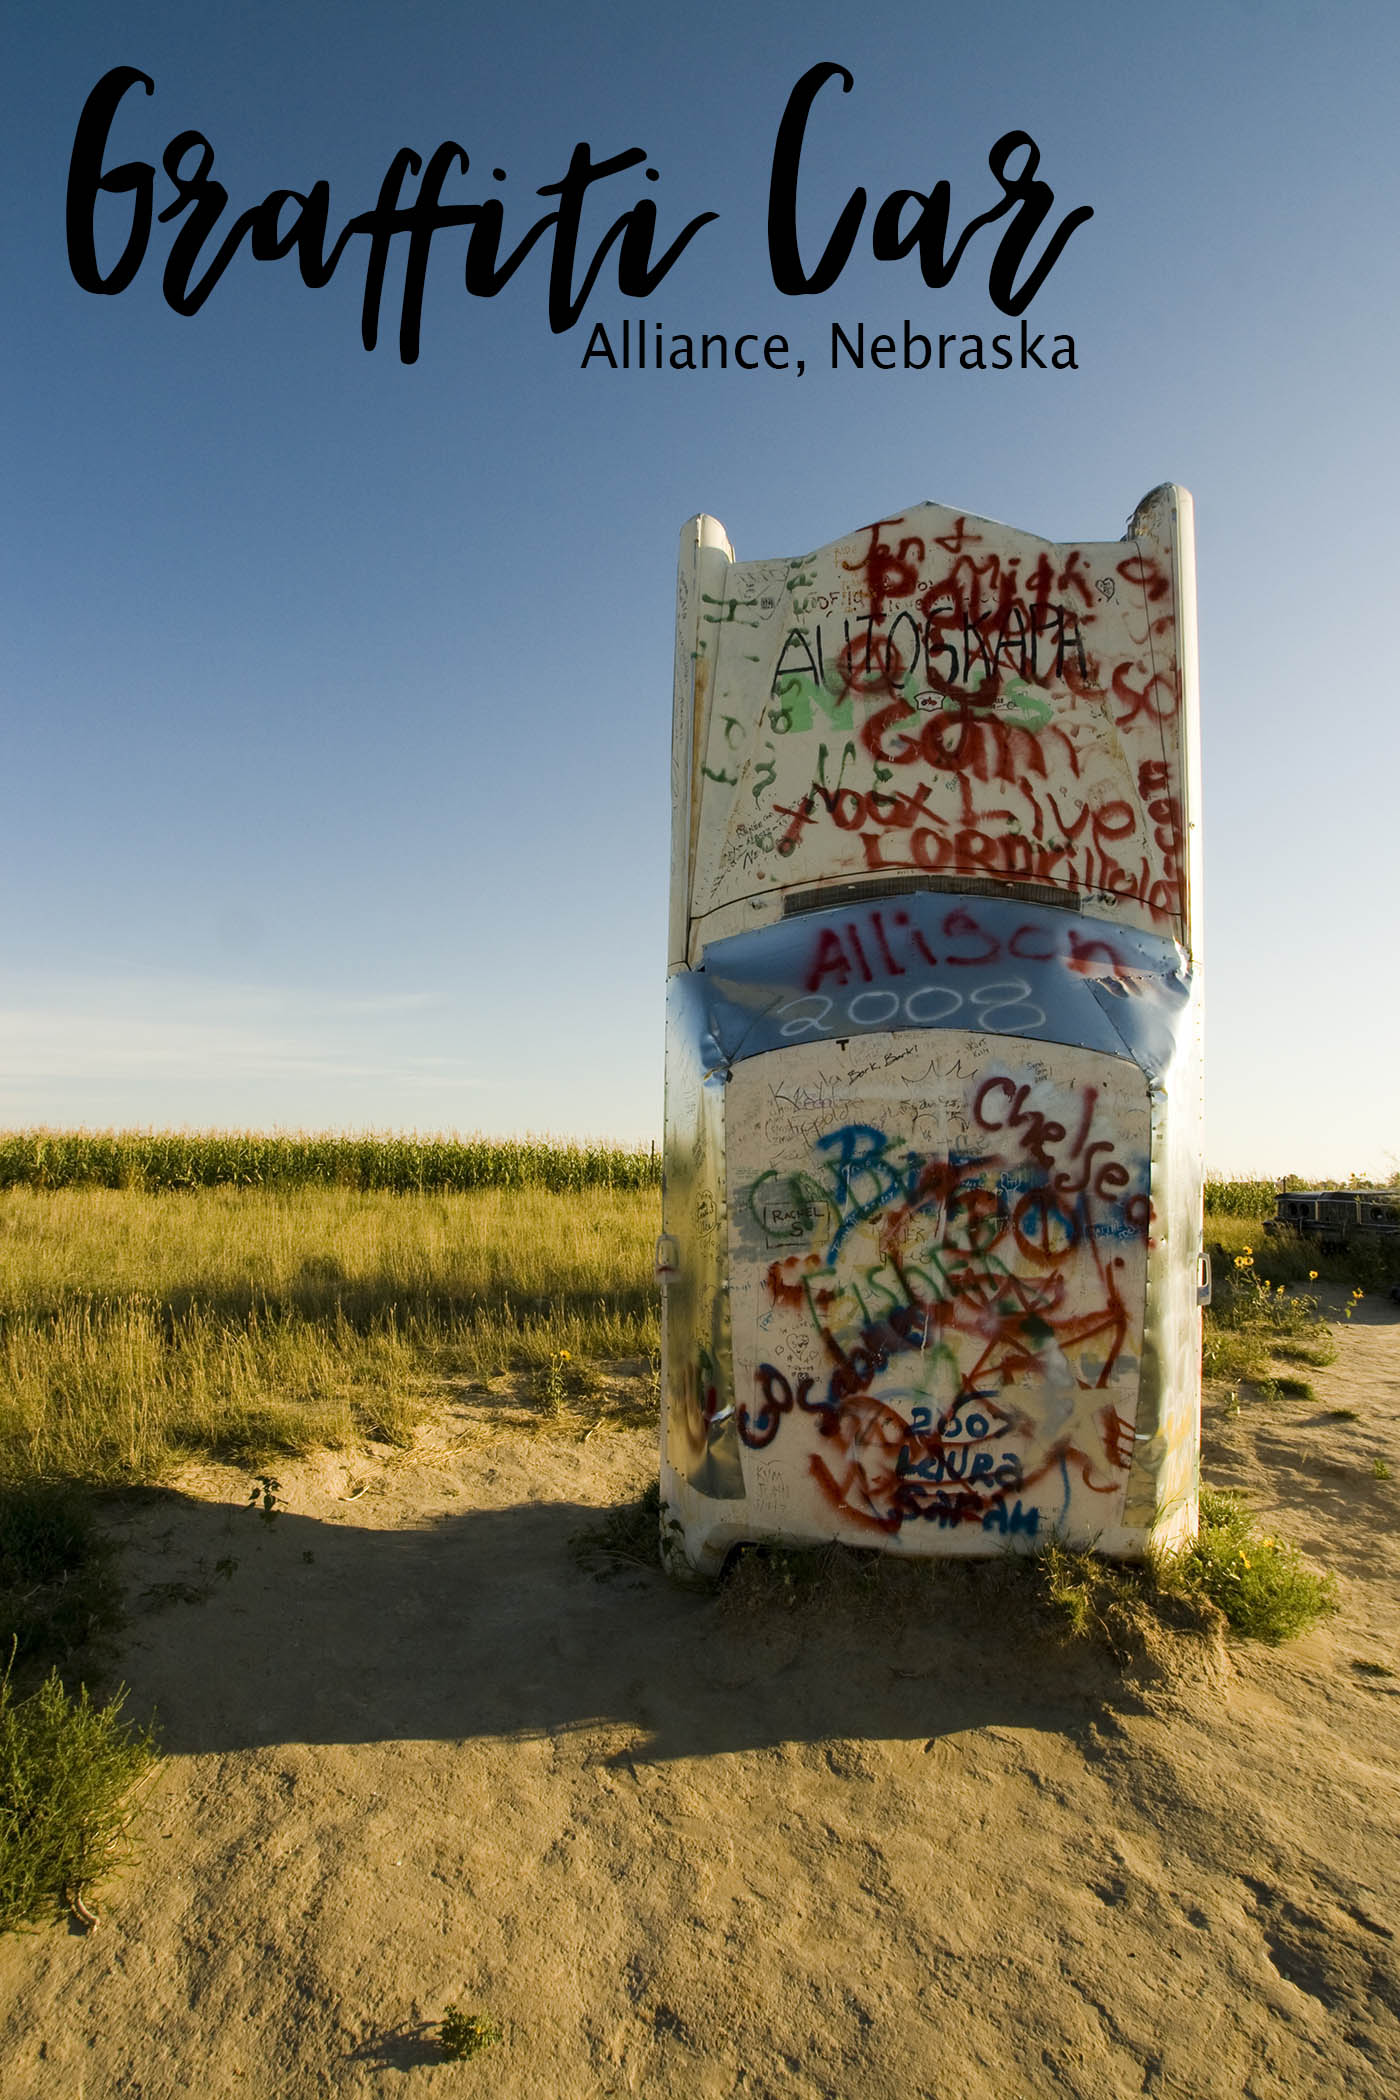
[730,1035,1152,1537]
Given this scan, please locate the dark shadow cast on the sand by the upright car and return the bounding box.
[109,1491,1158,1762]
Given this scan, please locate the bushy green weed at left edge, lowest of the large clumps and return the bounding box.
[0,1670,153,1932]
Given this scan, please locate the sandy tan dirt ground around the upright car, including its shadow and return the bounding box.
[0,1300,1400,2100]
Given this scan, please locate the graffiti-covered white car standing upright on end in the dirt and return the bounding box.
[659,487,1203,1571]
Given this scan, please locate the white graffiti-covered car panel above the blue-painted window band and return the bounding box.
[695,504,1186,930]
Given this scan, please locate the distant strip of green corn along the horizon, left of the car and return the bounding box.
[0,1130,661,1195]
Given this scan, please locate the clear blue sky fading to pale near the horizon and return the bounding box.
[0,0,1400,1174]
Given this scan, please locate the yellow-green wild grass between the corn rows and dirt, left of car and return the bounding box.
[0,1187,659,1485]
